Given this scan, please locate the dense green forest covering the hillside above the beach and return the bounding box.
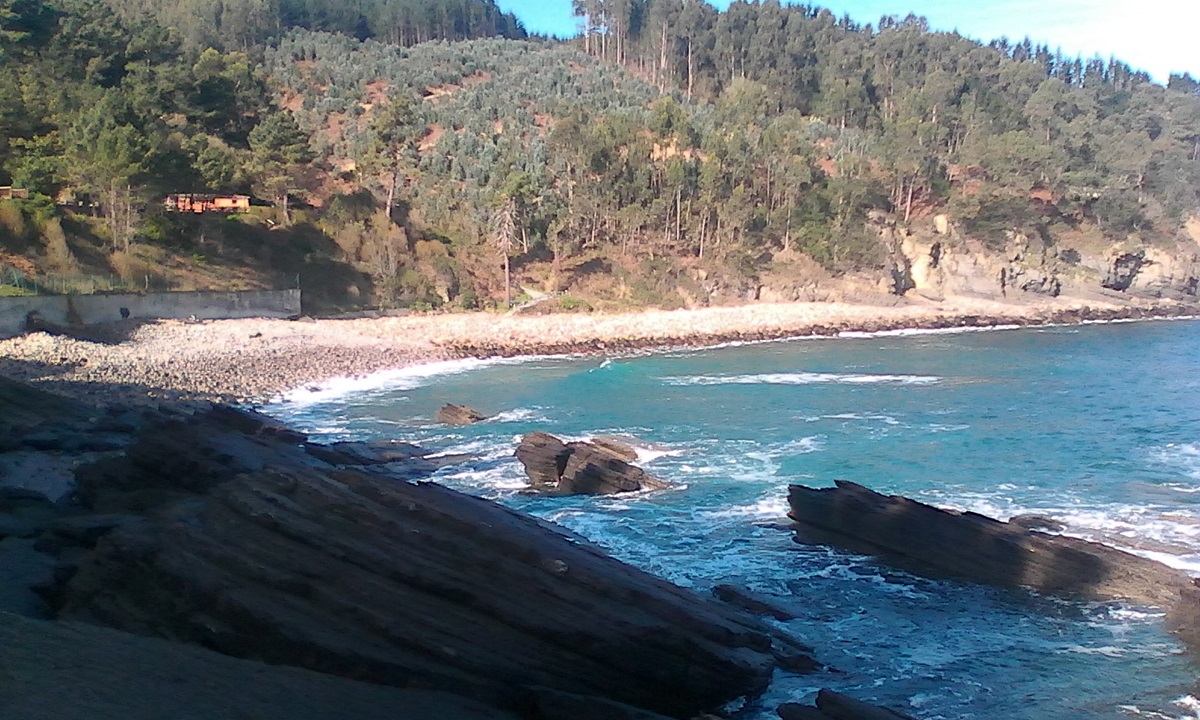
[0,0,1200,307]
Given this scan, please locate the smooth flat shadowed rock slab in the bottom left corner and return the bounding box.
[0,612,516,720]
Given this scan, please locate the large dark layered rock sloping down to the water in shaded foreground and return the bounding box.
[48,408,794,719]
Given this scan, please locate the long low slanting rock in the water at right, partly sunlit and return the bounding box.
[788,481,1192,607]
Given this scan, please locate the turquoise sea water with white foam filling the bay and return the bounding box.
[270,320,1200,720]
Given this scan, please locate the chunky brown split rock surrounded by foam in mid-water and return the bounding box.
[516,432,670,494]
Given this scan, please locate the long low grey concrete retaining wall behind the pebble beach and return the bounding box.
[0,290,300,337]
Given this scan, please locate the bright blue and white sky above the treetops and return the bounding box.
[498,0,1200,83]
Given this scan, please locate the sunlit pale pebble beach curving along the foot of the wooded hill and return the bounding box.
[0,298,1200,404]
